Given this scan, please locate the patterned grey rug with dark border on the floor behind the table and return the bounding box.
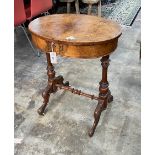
[56,0,141,26]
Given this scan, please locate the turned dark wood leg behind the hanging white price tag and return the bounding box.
[38,53,55,115]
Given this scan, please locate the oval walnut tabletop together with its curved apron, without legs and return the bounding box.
[29,14,121,58]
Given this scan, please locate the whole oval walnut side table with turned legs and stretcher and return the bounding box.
[29,14,121,136]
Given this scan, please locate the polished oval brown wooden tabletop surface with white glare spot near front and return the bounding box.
[29,14,121,57]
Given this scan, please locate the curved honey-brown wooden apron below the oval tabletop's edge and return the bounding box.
[32,34,118,59]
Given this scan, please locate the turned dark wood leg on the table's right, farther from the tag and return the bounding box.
[89,56,113,137]
